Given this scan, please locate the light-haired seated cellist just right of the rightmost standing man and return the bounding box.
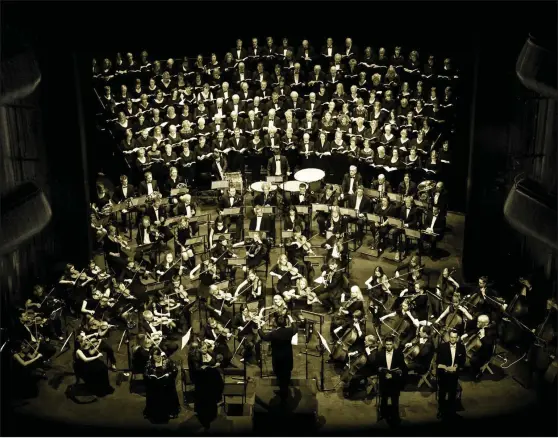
[461,315,498,380]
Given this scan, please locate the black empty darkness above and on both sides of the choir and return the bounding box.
[2,1,557,432]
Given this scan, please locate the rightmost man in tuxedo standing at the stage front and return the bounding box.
[436,330,467,418]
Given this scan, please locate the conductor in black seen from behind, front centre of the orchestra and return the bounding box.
[258,315,298,402]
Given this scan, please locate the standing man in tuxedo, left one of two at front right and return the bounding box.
[376,336,407,423]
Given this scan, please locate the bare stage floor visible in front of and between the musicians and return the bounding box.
[4,213,552,435]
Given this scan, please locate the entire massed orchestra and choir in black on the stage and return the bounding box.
[4,38,556,432]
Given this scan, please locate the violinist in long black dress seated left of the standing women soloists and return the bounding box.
[74,335,114,397]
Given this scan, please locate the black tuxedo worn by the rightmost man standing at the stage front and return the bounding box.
[436,342,467,414]
